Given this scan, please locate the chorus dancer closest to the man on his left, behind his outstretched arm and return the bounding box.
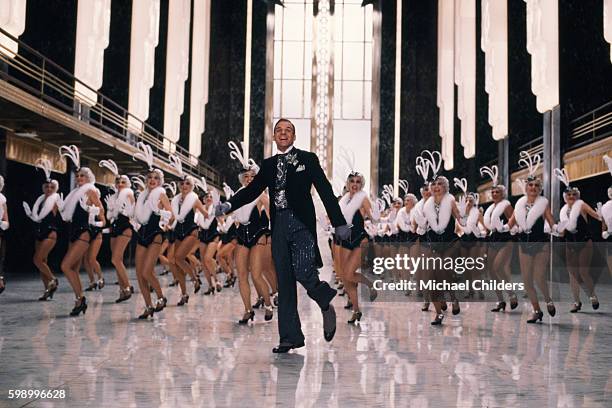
[228,142,273,324]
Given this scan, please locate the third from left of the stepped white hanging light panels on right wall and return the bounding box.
[480,0,508,140]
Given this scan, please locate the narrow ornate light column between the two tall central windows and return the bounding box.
[311,0,333,177]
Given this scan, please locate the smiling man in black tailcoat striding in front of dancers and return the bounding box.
[215,119,350,353]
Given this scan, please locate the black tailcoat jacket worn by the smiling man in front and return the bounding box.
[229,147,346,268]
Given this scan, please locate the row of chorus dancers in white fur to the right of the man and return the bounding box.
[325,151,612,325]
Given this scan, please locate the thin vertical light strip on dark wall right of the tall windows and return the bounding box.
[393,0,403,197]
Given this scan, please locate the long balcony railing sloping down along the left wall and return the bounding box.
[0,28,222,186]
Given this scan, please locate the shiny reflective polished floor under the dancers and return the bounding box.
[0,260,612,408]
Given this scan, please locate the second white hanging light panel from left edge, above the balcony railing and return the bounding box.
[74,0,111,106]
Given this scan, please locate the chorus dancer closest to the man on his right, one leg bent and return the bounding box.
[338,167,380,324]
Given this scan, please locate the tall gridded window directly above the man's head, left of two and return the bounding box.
[273,0,313,150]
